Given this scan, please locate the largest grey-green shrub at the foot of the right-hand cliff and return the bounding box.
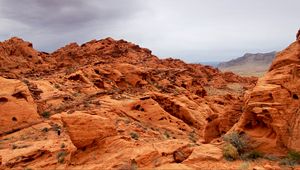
[223,132,250,154]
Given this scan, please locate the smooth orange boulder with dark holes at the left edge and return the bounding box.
[0,77,41,135]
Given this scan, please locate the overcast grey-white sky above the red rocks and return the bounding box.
[0,0,300,62]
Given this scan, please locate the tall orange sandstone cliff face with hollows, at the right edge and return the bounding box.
[236,41,300,153]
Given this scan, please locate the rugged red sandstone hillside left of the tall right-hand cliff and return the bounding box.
[0,35,288,169]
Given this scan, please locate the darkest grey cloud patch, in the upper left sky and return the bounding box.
[0,0,141,32]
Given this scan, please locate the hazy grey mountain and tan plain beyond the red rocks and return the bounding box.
[217,51,276,77]
